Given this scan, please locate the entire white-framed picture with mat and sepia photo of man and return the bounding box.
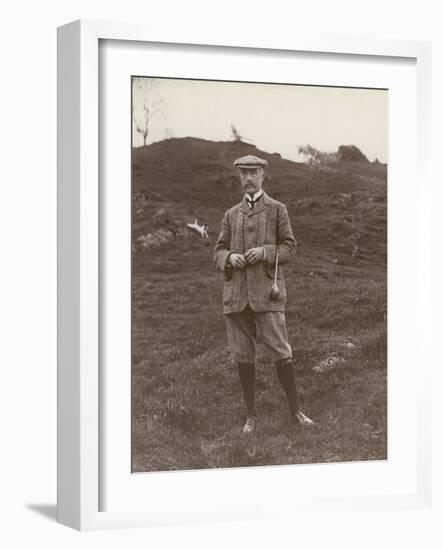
[58,21,431,530]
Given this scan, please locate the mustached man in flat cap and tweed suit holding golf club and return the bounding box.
[214,155,314,433]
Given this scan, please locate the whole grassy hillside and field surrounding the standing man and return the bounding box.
[132,138,387,472]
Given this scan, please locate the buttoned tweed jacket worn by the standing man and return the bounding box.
[214,192,296,314]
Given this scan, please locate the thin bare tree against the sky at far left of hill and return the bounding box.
[132,77,163,145]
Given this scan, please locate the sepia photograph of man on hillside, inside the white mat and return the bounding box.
[128,75,388,473]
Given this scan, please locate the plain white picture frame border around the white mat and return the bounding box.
[58,21,431,530]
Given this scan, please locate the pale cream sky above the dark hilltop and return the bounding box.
[133,78,388,162]
